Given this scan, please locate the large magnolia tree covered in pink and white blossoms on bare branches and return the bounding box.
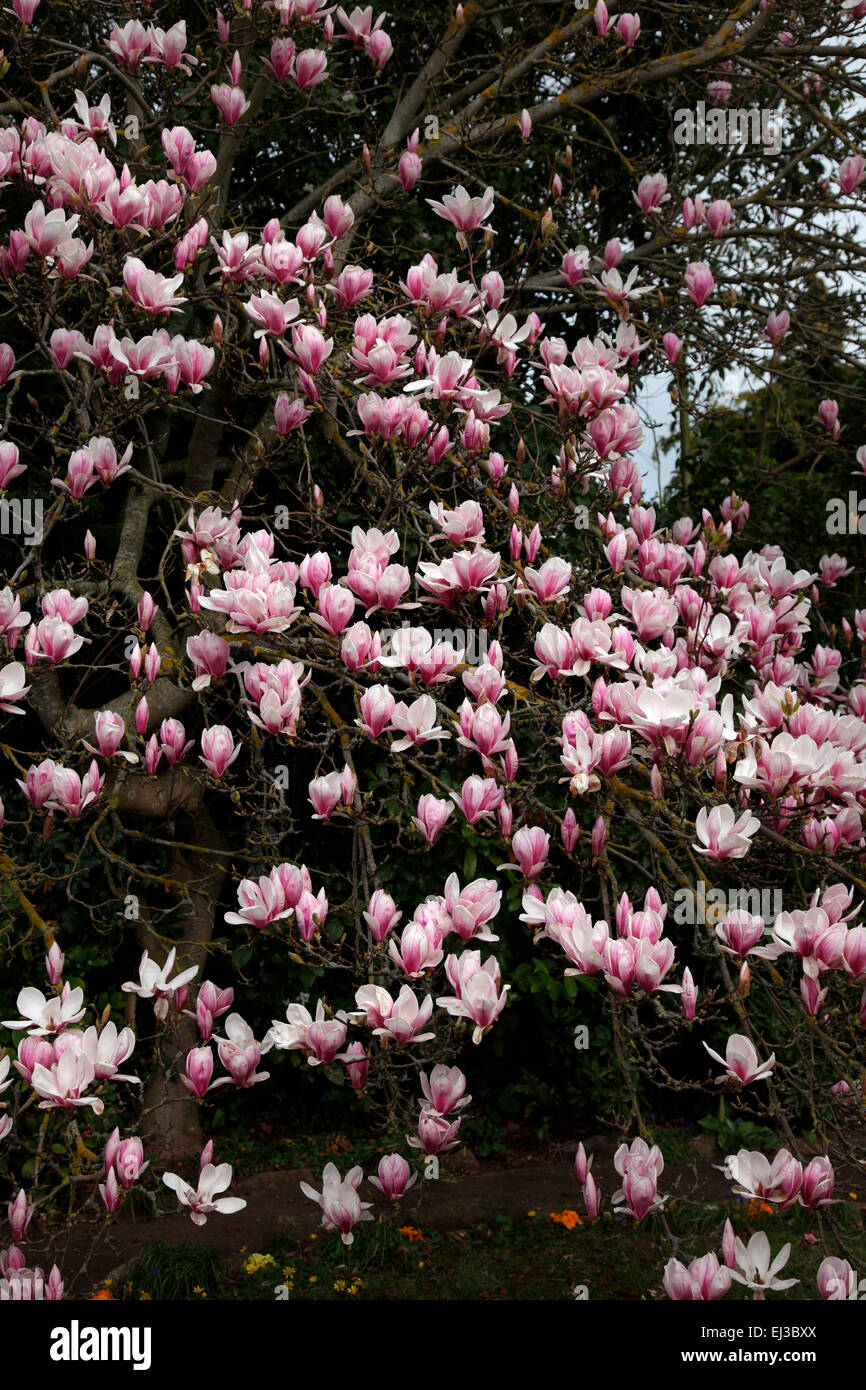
[0,0,866,1298]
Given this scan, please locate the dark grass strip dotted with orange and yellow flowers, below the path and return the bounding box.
[111,1200,866,1301]
